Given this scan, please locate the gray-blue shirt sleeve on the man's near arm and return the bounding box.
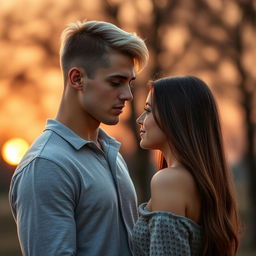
[9,158,76,256]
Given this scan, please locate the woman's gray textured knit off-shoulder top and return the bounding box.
[132,203,202,256]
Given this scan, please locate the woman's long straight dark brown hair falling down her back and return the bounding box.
[151,76,240,256]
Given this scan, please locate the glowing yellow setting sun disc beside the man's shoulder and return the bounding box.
[2,138,29,165]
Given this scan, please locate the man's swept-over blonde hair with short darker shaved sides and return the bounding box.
[60,21,148,79]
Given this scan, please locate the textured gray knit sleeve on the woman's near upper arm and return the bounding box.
[149,215,191,256]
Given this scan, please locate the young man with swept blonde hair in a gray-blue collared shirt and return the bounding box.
[10,21,148,256]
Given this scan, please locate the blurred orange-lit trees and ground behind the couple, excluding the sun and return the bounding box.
[0,0,256,256]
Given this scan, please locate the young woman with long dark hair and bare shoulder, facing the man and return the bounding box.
[132,76,239,256]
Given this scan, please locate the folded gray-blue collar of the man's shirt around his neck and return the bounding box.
[45,119,120,150]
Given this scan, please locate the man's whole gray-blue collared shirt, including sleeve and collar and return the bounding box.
[9,120,137,256]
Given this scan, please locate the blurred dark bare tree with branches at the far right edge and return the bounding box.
[188,0,256,246]
